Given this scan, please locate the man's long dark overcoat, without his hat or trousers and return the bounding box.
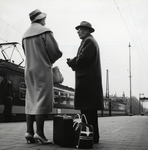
[67,35,103,110]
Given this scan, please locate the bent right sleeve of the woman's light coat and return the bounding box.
[42,32,62,64]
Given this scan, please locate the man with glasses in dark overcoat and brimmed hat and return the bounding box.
[67,21,103,143]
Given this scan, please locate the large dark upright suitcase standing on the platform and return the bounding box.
[53,115,75,147]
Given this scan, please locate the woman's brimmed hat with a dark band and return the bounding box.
[29,9,47,22]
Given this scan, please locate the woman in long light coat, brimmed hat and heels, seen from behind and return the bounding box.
[22,9,62,144]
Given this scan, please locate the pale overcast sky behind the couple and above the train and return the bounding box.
[0,0,148,103]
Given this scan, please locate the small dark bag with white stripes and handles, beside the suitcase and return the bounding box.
[73,114,94,149]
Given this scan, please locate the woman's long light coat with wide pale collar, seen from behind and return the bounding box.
[22,23,62,115]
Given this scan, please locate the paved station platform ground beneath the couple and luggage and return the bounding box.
[0,116,148,150]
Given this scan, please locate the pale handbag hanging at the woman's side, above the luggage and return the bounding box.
[52,66,64,84]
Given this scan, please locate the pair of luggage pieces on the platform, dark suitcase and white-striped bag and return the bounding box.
[53,114,94,149]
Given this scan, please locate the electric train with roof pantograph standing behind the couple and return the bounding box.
[0,42,126,122]
